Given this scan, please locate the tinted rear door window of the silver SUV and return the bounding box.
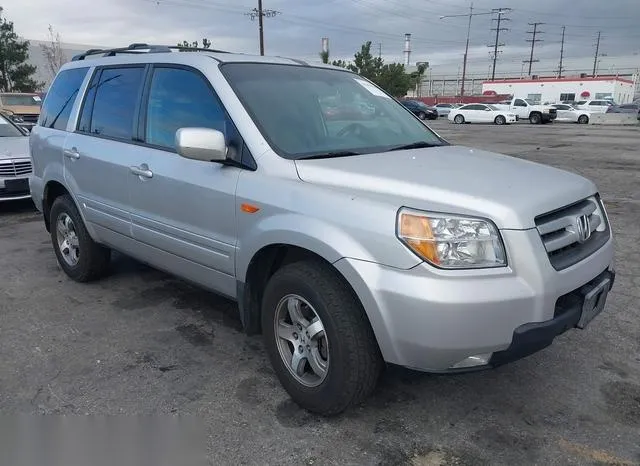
[88,67,144,140]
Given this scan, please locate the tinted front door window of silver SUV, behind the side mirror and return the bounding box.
[145,67,228,149]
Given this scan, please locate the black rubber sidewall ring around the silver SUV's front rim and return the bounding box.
[262,269,364,414]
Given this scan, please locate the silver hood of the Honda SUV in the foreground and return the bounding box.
[296,146,596,230]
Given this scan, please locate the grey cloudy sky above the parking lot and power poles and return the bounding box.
[2,0,640,76]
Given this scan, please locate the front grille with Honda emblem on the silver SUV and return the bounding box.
[535,196,611,270]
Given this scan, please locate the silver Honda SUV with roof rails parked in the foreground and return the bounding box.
[30,44,615,415]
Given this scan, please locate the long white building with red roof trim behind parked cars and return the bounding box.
[482,75,638,104]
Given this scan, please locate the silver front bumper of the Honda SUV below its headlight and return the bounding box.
[335,230,613,372]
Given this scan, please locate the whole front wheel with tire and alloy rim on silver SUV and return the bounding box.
[262,260,383,415]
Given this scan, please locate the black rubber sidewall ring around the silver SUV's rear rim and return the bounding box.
[50,195,100,281]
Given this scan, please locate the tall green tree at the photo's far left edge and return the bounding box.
[0,7,43,92]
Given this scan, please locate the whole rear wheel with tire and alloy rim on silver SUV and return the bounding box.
[50,195,111,282]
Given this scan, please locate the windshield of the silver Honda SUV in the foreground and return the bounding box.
[220,63,445,159]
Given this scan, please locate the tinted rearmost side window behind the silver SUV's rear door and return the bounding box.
[38,68,89,130]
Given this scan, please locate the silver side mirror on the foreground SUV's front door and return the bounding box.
[176,128,227,162]
